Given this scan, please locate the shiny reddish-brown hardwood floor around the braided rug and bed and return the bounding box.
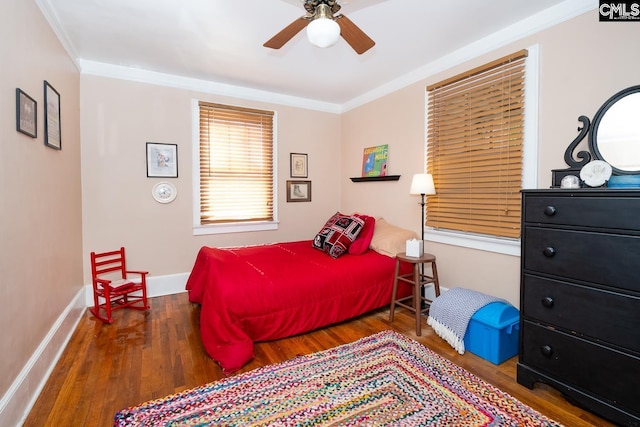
[24,293,613,427]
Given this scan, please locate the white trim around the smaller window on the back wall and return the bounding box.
[191,99,280,236]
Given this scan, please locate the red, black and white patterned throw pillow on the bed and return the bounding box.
[313,212,364,258]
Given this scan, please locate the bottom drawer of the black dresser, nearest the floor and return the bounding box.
[520,321,640,416]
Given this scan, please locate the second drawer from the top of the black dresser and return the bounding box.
[523,227,640,291]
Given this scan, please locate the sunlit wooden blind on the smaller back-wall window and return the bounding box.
[199,102,274,225]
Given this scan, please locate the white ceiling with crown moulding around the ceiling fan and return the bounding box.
[36,0,597,110]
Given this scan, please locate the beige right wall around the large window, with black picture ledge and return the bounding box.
[341,10,640,306]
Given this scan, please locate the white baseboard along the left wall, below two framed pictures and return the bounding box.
[0,289,86,426]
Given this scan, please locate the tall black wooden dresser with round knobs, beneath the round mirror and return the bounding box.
[517,189,640,426]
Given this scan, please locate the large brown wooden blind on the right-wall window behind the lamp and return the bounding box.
[426,50,527,238]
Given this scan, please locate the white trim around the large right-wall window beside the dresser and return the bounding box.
[423,44,540,256]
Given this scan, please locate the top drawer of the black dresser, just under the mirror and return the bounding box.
[524,195,640,230]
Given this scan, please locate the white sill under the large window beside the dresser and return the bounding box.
[424,230,520,257]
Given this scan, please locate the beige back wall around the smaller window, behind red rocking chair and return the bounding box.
[81,75,342,283]
